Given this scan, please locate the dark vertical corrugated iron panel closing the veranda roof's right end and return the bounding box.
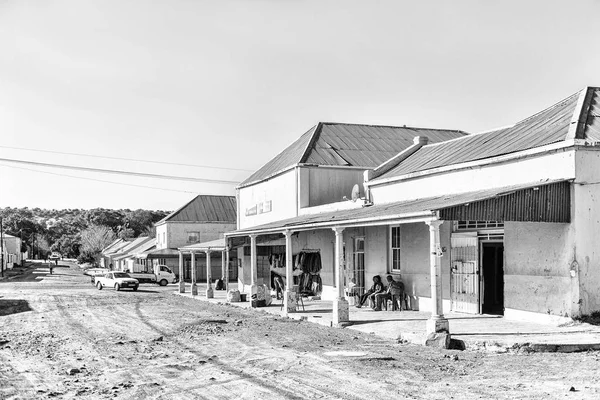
[439,182,571,222]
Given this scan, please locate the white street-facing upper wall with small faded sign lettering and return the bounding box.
[238,169,298,229]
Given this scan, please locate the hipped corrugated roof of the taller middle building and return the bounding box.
[239,122,466,187]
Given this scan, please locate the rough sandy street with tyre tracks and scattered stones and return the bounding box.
[0,264,600,399]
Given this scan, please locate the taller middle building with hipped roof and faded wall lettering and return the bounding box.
[228,123,466,316]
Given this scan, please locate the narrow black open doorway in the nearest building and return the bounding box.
[481,242,504,315]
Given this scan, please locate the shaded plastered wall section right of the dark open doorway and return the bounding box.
[504,222,573,316]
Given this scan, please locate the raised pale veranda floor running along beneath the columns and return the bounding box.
[177,284,600,352]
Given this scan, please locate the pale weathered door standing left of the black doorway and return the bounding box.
[450,232,481,314]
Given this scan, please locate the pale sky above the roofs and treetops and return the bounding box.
[0,0,600,210]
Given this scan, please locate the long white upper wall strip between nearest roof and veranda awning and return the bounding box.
[371,150,575,204]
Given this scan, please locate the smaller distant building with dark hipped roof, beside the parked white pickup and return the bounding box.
[155,195,237,281]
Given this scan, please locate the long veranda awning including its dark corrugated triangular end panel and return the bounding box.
[225,179,571,237]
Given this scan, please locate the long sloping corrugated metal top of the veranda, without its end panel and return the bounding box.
[226,180,570,236]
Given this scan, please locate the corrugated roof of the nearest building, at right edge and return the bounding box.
[377,87,600,179]
